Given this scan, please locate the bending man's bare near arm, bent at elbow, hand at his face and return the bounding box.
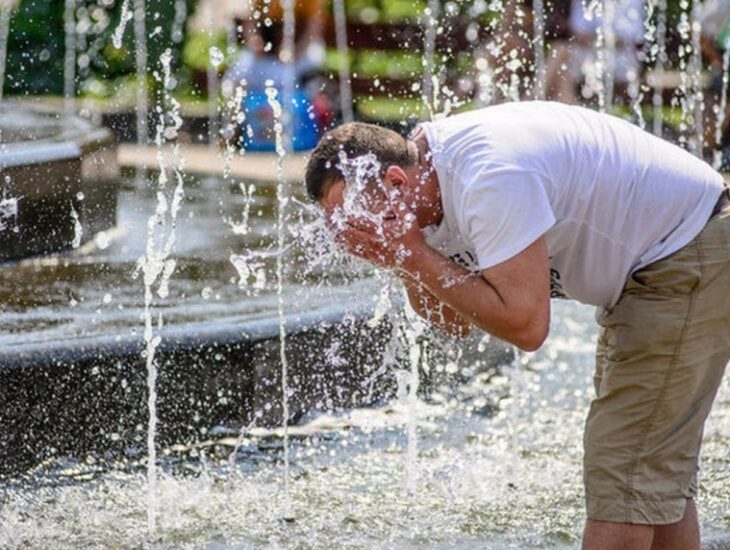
[338,207,550,350]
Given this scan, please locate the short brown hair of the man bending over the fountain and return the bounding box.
[304,122,415,201]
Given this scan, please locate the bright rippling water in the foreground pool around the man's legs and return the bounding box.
[0,302,730,548]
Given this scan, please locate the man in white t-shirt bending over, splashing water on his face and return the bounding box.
[306,102,730,550]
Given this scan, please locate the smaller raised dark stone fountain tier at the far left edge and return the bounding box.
[0,102,119,261]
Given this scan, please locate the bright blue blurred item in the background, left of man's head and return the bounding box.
[241,91,320,151]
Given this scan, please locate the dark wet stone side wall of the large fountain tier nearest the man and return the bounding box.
[0,302,393,478]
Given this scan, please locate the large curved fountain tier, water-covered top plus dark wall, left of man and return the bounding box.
[0,169,512,484]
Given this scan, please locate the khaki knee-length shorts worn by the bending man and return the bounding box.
[584,210,730,525]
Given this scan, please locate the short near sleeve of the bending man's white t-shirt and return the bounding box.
[460,169,555,270]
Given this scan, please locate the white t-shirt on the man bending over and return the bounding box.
[422,101,723,307]
